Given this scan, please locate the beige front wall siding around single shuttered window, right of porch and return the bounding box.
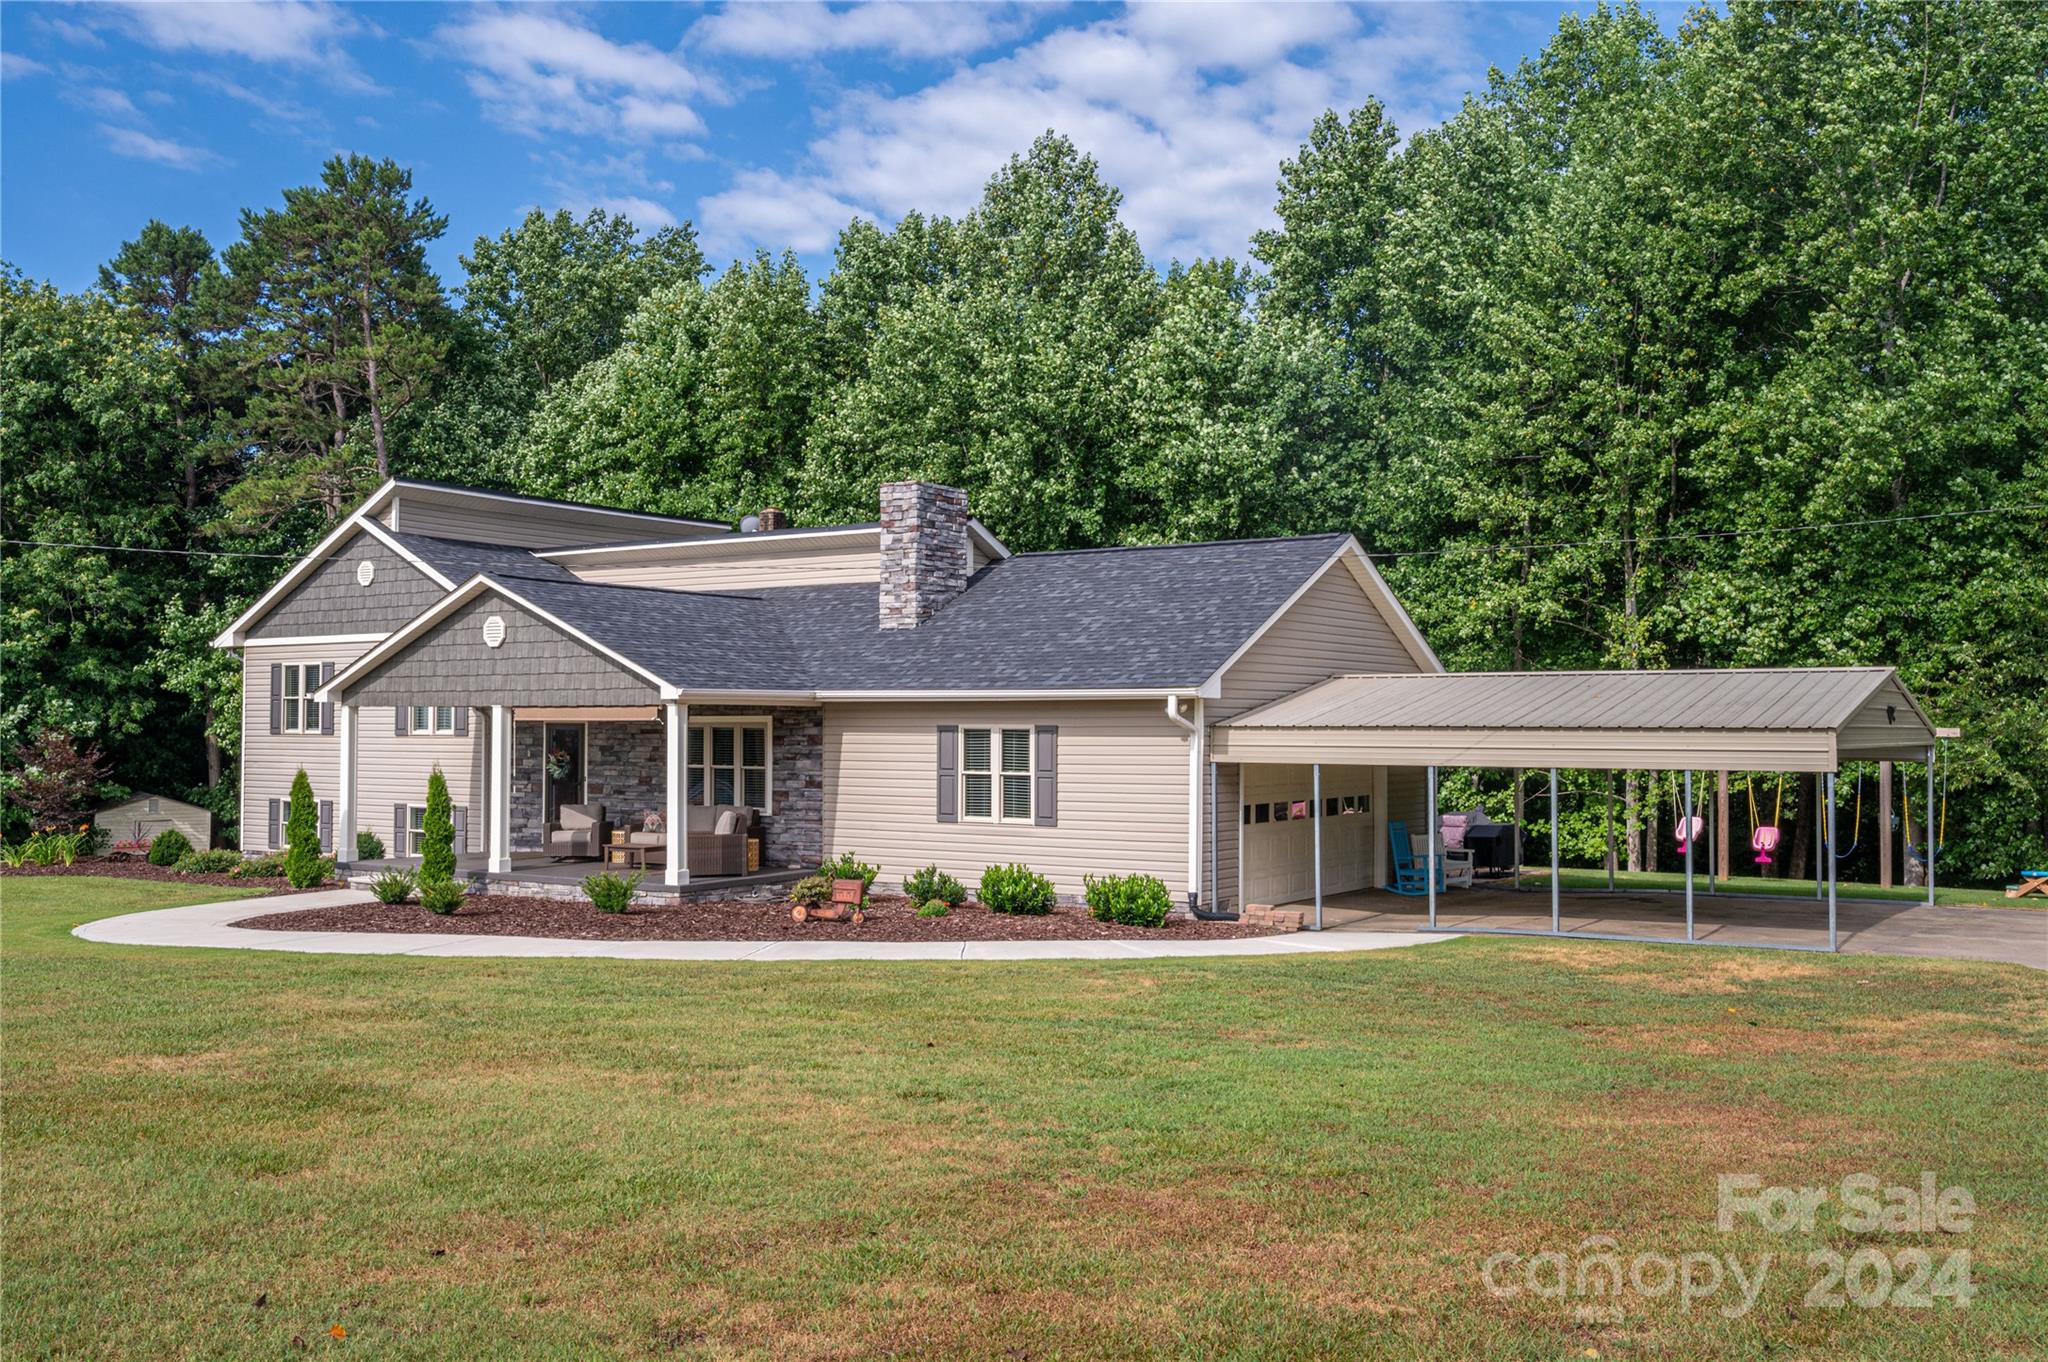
[825,700,1188,901]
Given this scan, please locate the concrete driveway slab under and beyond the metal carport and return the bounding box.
[1288,887,2048,969]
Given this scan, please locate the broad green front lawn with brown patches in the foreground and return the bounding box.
[12,879,2048,1358]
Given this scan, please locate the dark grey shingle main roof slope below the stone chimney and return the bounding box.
[475,535,1343,690]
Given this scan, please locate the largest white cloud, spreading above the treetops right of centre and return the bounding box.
[698,4,1485,258]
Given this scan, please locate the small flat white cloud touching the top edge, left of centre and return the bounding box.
[690,0,1028,59]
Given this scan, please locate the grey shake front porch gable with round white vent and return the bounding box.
[346,592,659,705]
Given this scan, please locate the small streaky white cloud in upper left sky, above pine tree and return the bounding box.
[436,8,717,139]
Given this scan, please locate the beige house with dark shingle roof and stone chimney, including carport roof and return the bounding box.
[215,479,1933,925]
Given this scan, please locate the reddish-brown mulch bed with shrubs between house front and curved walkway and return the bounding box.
[233,895,1272,942]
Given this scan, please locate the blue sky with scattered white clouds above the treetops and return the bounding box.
[0,0,1681,289]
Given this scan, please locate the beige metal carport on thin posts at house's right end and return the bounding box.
[1210,668,1937,950]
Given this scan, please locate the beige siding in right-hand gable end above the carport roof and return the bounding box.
[1204,561,1419,723]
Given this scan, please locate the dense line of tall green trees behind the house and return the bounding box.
[0,2,2048,877]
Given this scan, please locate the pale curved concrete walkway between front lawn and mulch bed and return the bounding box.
[72,889,1450,961]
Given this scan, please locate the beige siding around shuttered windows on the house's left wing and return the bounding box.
[242,643,483,858]
